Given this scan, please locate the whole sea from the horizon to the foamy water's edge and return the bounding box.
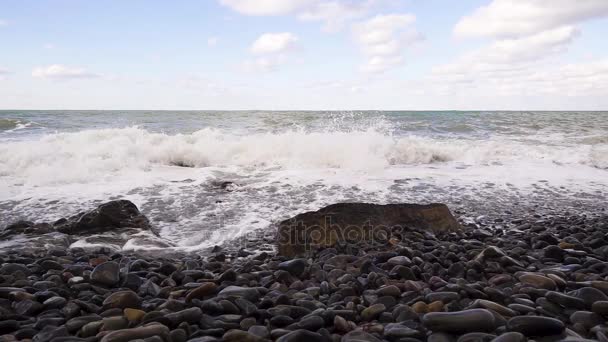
[0,110,608,251]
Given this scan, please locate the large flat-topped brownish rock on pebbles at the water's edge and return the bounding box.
[277,203,460,256]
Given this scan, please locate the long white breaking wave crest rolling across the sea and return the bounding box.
[0,127,608,183]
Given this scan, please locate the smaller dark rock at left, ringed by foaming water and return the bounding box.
[55,200,151,234]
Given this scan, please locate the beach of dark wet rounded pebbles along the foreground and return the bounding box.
[0,199,608,342]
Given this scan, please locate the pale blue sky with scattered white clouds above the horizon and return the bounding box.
[0,0,608,110]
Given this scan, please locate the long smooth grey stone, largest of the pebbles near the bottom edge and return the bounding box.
[422,309,496,334]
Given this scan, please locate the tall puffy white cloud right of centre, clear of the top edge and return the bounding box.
[353,14,423,73]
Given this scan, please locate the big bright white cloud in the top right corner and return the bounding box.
[454,0,608,38]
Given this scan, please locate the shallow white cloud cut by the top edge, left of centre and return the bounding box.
[220,0,316,16]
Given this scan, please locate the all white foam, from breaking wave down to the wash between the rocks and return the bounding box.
[0,125,608,249]
